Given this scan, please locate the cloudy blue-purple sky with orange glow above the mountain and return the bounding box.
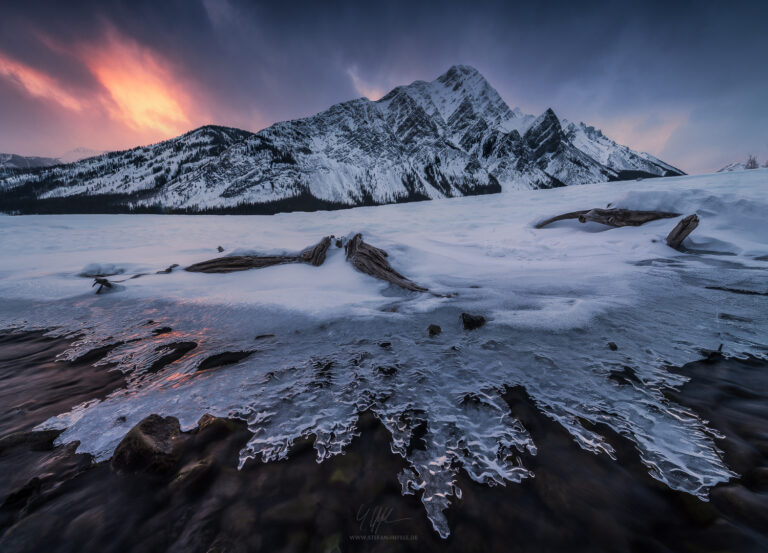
[0,0,768,173]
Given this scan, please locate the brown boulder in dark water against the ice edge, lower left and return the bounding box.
[112,415,182,473]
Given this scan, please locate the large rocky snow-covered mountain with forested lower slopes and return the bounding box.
[0,65,682,212]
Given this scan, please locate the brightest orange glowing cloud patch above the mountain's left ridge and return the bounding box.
[82,34,191,136]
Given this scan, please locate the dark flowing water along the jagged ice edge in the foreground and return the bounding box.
[0,334,768,552]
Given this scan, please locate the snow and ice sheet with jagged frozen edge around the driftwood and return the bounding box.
[0,170,768,536]
